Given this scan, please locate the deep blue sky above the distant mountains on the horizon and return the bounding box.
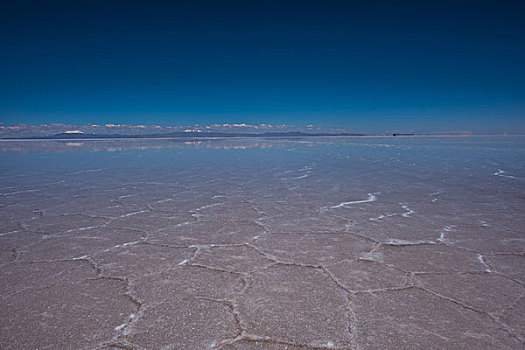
[0,0,525,133]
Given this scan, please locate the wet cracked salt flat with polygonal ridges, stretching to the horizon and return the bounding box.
[0,137,525,349]
